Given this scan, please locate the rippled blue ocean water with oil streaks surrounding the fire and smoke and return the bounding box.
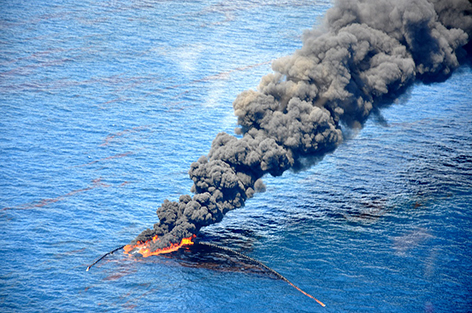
[0,0,472,312]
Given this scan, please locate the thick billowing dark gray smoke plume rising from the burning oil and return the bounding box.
[132,0,472,251]
